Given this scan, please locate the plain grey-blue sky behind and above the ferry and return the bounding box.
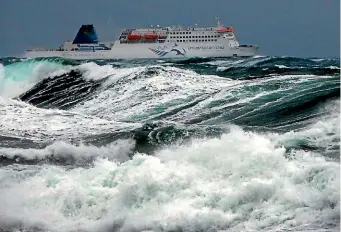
[0,0,340,57]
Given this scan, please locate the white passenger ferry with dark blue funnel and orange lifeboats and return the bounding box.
[25,19,259,60]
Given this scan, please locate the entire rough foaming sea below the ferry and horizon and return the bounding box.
[0,56,340,232]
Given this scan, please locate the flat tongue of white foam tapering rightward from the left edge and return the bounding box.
[0,96,141,140]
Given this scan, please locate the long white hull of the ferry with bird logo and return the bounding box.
[26,42,258,60]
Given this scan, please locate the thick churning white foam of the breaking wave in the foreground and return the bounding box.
[0,127,340,231]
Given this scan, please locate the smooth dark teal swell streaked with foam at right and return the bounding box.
[181,77,340,132]
